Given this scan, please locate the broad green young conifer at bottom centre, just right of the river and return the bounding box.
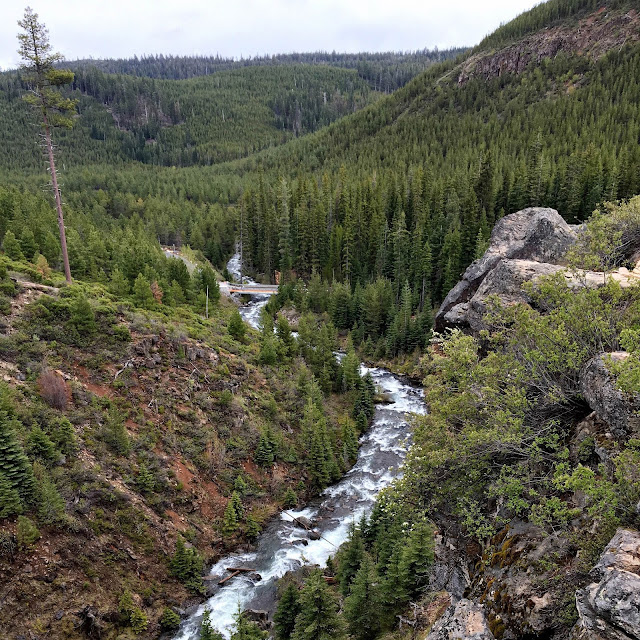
[291,569,346,640]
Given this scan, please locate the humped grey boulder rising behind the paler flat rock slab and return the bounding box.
[435,207,577,331]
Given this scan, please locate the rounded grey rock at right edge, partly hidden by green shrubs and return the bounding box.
[580,351,640,438]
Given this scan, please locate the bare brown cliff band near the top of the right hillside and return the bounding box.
[458,8,640,85]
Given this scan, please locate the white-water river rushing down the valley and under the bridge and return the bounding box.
[176,256,425,640]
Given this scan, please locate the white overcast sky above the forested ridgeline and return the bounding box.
[0,0,538,69]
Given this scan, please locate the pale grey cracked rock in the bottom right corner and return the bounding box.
[571,529,640,640]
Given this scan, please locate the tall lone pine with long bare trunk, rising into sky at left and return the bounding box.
[18,7,76,283]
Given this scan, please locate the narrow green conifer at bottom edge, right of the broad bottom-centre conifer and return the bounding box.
[344,553,380,640]
